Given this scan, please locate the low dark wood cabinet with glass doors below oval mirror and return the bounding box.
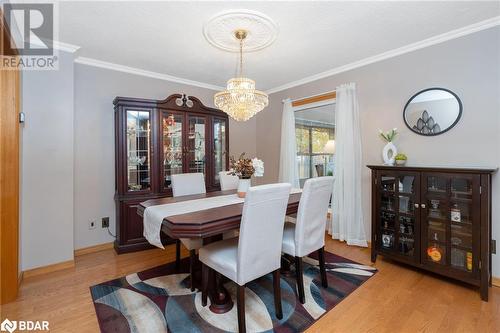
[368,165,496,301]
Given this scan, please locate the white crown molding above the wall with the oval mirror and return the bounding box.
[266,16,500,94]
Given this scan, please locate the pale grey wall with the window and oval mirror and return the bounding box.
[257,27,500,277]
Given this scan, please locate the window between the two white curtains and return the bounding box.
[295,103,335,187]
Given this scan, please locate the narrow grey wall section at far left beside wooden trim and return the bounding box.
[21,52,74,270]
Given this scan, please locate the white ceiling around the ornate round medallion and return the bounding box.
[59,1,500,90]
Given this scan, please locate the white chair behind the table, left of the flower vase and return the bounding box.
[171,173,207,291]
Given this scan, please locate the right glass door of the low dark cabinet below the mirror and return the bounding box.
[421,173,480,274]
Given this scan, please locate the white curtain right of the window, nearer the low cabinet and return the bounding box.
[331,83,368,247]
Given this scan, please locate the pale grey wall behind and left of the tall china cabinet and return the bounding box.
[20,52,257,270]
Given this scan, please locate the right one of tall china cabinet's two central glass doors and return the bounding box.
[186,115,207,174]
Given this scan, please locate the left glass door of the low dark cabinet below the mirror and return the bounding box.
[377,172,420,261]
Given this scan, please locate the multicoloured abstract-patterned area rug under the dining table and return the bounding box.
[90,252,377,333]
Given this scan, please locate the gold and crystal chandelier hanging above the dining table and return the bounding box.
[214,30,269,121]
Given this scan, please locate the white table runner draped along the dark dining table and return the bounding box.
[143,189,302,249]
